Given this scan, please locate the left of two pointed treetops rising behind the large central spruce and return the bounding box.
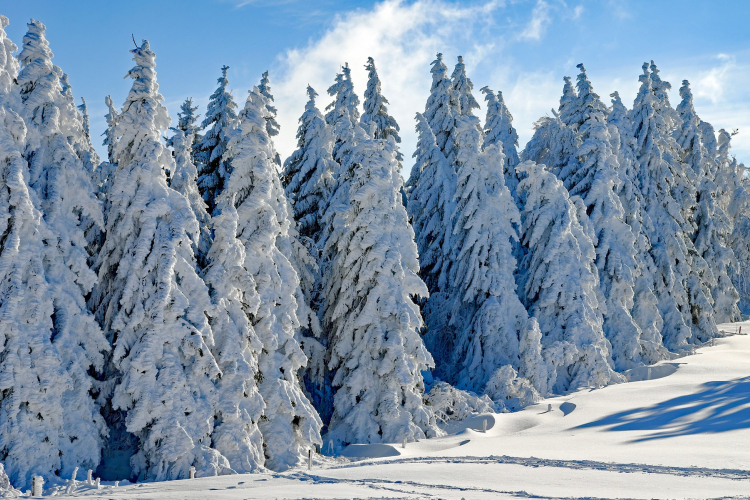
[325,64,359,165]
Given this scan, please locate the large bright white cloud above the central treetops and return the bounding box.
[271,0,502,169]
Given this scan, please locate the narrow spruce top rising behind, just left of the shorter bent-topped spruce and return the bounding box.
[481,87,521,199]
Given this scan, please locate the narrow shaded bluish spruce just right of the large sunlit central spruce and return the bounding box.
[406,113,457,379]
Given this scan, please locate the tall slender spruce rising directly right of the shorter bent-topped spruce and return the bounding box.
[560,64,659,370]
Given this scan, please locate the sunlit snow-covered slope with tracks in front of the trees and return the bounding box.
[45,322,750,500]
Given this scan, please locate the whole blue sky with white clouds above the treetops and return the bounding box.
[5,0,750,169]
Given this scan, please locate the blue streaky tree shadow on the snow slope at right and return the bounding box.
[576,376,750,442]
